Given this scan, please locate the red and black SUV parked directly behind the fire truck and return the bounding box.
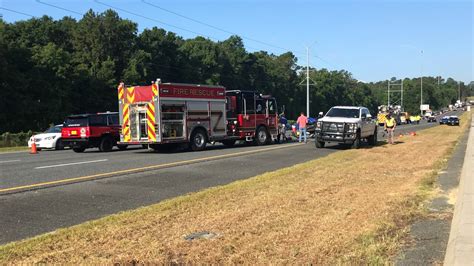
[61,112,127,152]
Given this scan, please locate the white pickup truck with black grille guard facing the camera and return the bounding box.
[315,106,377,149]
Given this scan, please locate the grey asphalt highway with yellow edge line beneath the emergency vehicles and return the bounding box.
[0,111,460,243]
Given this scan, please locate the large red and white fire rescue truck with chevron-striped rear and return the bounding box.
[118,79,278,151]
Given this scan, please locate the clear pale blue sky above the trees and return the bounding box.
[0,0,474,82]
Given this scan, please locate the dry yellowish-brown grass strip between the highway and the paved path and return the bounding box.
[0,113,470,264]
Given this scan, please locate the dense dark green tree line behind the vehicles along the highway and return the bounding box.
[0,10,473,133]
